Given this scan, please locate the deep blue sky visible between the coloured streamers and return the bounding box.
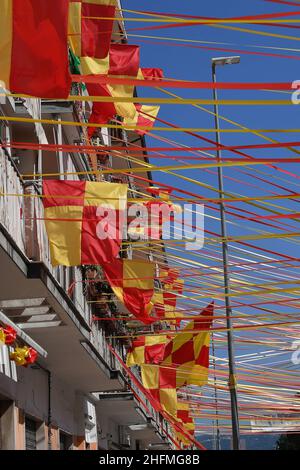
[123,0,300,258]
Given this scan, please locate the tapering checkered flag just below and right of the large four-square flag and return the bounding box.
[103,259,155,324]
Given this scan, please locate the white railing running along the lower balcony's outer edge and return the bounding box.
[0,149,173,444]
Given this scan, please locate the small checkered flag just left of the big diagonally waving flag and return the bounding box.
[126,335,169,367]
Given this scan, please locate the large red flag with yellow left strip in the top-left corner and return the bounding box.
[0,0,71,98]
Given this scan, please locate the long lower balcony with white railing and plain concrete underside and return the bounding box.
[0,114,175,448]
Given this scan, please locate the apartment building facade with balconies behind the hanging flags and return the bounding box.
[0,3,172,450]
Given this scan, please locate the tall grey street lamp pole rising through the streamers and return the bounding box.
[212,63,240,450]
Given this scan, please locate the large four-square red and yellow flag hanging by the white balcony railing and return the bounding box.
[43,180,127,266]
